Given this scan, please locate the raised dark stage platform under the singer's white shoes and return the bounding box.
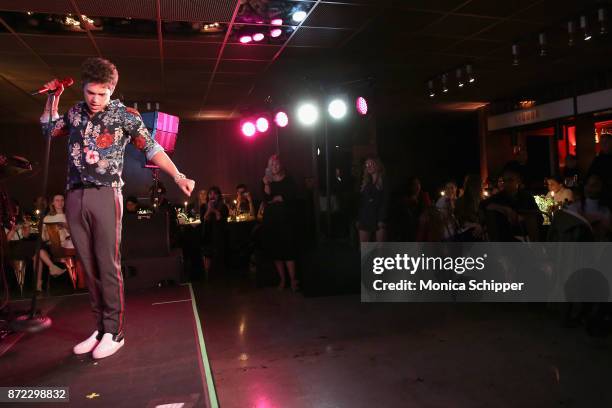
[0,286,214,408]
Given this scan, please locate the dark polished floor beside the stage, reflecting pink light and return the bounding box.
[194,282,612,408]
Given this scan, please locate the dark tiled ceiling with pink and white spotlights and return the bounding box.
[0,0,612,121]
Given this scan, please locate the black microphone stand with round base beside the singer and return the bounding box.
[11,94,55,333]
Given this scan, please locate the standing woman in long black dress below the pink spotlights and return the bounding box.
[262,155,298,292]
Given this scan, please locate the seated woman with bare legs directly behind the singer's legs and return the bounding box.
[33,194,74,291]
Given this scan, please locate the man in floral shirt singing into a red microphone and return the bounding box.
[40,58,195,359]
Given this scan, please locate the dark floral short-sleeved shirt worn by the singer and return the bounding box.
[42,100,164,190]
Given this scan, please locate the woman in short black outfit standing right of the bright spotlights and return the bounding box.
[357,157,388,242]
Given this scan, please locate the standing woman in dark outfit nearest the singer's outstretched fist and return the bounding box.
[200,186,229,278]
